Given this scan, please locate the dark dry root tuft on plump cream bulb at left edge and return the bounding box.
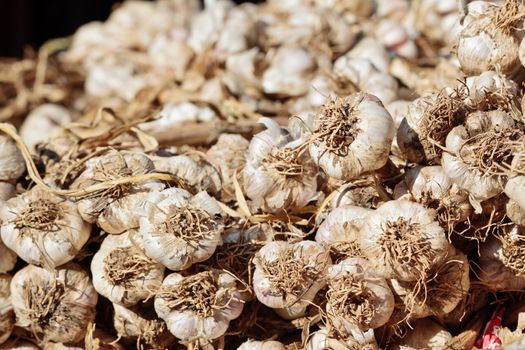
[13,199,64,232]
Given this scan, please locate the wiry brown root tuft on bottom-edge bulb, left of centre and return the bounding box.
[157,271,234,318]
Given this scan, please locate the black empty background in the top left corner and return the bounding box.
[0,0,260,57]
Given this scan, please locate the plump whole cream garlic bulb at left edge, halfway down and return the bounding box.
[0,186,91,267]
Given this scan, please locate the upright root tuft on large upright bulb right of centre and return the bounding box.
[311,98,363,157]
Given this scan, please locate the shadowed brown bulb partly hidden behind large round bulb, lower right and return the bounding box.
[390,246,470,319]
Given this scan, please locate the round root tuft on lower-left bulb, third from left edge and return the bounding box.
[104,247,153,286]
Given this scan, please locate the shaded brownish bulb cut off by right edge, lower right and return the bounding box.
[477,225,525,291]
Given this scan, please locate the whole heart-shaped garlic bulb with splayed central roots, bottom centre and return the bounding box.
[252,241,331,319]
